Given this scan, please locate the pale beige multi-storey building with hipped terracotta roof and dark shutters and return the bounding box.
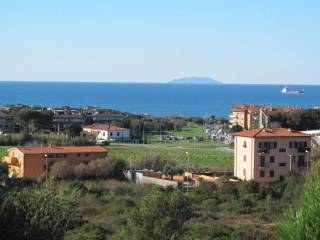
[234,128,311,183]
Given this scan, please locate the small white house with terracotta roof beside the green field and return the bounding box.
[82,123,130,141]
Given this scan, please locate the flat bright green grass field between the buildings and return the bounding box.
[0,124,233,169]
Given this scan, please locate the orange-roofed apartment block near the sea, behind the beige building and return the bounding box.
[229,104,303,130]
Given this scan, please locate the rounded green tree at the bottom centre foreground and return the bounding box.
[118,188,192,240]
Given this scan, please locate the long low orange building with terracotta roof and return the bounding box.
[3,146,107,177]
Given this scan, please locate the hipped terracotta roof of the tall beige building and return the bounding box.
[233,128,311,138]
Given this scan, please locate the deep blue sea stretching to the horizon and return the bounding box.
[0,81,320,118]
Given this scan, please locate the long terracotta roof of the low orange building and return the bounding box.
[17,146,107,154]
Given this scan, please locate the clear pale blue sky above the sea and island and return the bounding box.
[0,0,320,84]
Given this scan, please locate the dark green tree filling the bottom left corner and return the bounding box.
[0,183,82,240]
